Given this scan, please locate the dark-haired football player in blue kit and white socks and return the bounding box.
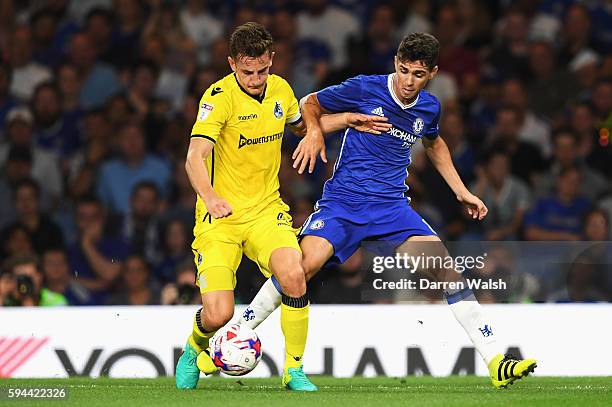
[239,33,536,388]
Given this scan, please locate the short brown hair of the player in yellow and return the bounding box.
[230,22,273,59]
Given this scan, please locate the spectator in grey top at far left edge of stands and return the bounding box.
[0,107,62,200]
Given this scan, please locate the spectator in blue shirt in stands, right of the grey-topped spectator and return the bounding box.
[525,167,591,241]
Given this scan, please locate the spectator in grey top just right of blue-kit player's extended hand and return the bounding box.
[471,150,530,240]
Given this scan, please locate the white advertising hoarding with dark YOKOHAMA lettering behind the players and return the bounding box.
[0,304,612,377]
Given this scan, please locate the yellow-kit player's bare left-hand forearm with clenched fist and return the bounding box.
[185,137,232,219]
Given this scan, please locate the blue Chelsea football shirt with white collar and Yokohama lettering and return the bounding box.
[317,74,440,202]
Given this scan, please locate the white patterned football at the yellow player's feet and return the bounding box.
[210,324,262,376]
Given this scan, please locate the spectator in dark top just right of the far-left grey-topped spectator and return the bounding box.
[32,83,81,158]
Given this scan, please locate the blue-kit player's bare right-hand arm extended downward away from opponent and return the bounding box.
[422,136,488,220]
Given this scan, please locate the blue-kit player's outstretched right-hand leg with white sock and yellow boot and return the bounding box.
[397,235,536,388]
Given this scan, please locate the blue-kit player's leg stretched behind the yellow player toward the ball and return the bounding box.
[238,235,334,329]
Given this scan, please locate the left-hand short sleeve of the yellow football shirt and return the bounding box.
[191,85,230,143]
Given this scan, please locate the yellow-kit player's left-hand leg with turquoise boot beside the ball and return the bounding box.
[176,228,242,389]
